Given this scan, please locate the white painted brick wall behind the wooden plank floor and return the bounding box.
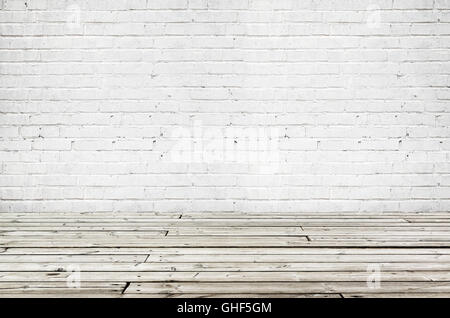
[0,0,450,213]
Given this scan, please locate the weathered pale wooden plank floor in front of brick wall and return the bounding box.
[0,212,450,298]
